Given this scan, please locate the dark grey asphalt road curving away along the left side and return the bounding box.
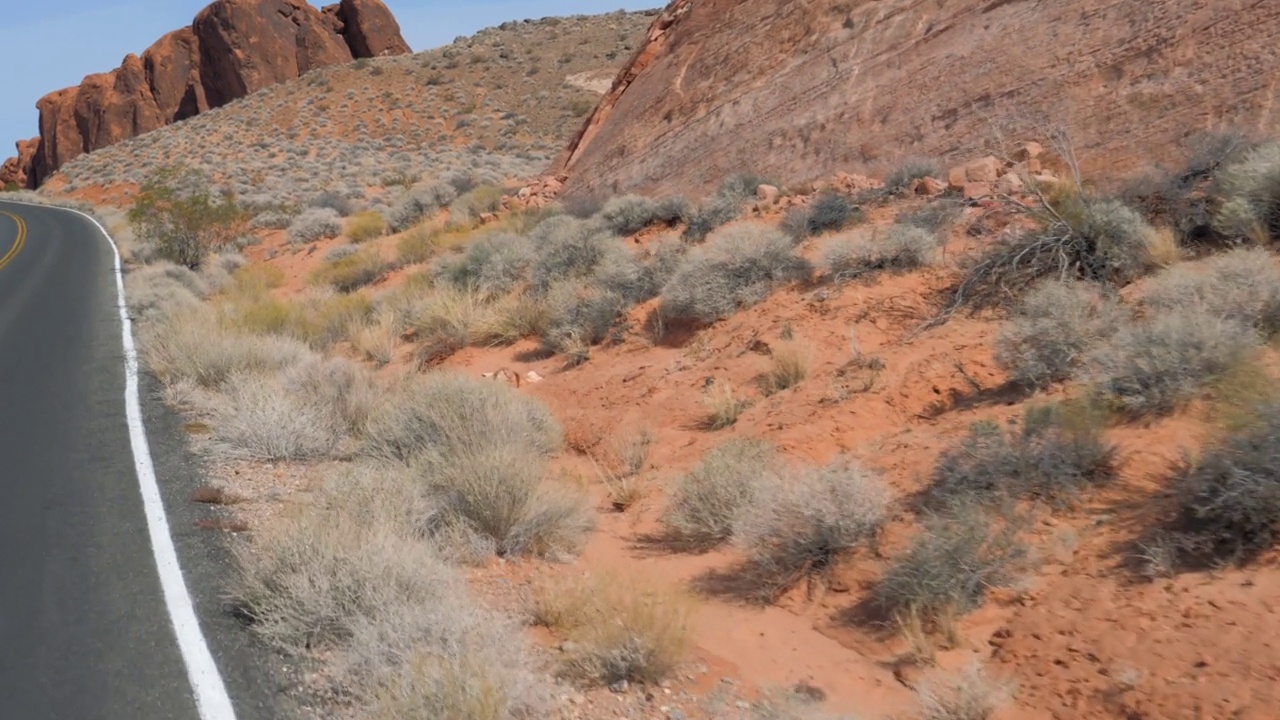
[0,202,287,720]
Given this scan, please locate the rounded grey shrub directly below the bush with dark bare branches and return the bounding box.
[996,281,1123,388]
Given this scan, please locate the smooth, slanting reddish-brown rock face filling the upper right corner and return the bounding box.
[552,0,1280,196]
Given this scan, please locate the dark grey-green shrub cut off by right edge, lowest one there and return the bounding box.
[1172,401,1280,564]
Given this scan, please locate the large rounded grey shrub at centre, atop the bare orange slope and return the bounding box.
[659,223,813,322]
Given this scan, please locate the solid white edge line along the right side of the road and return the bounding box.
[5,198,236,720]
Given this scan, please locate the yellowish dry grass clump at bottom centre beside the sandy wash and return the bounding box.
[531,575,694,685]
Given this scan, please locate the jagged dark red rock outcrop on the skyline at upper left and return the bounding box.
[8,0,410,187]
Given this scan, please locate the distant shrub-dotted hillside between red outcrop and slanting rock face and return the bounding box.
[50,13,653,210]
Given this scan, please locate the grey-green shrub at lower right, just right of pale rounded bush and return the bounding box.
[874,503,1028,633]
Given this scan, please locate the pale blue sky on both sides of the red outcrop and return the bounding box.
[0,0,666,160]
